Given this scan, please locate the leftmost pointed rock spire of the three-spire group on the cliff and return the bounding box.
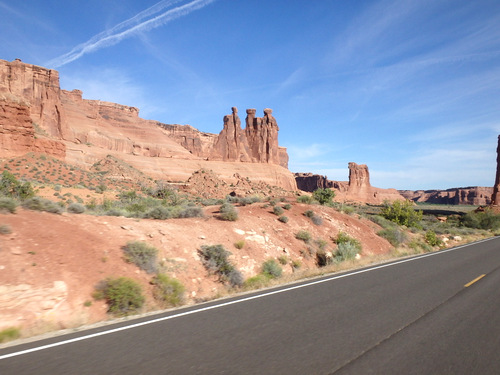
[210,107,252,162]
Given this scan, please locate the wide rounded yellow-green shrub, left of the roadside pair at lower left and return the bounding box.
[94,277,145,315]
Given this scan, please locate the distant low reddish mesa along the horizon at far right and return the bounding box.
[399,186,493,206]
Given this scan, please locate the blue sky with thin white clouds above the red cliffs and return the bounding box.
[0,0,500,189]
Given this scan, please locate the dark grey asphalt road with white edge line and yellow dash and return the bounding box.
[0,238,500,375]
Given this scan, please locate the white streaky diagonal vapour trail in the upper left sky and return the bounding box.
[46,0,216,68]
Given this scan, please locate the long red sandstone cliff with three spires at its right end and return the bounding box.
[0,60,297,190]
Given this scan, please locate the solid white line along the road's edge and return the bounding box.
[0,237,495,360]
